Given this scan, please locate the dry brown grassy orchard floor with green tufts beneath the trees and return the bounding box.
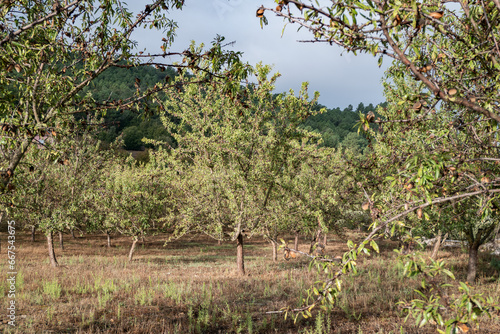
[0,232,500,334]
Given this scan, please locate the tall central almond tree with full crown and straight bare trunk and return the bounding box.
[158,65,324,274]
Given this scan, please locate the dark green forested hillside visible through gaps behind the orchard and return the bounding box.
[86,66,376,153]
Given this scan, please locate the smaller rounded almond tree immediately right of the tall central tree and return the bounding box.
[271,145,355,253]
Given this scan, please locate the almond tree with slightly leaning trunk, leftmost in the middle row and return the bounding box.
[8,133,111,266]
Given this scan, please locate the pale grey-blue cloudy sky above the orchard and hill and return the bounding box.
[129,0,390,108]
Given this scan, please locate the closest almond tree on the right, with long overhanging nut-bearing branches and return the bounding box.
[257,0,500,330]
